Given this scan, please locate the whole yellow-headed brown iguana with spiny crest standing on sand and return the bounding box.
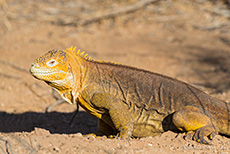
[30,47,230,144]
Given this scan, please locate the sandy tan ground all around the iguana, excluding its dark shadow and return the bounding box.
[0,0,230,154]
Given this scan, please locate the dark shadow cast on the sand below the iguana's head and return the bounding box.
[0,111,97,134]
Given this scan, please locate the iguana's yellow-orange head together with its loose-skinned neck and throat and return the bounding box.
[30,47,85,103]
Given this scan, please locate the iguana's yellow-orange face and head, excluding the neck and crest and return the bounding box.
[30,50,72,88]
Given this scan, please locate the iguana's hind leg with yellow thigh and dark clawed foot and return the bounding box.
[172,106,216,144]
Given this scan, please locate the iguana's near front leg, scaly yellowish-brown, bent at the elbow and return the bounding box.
[90,93,133,139]
